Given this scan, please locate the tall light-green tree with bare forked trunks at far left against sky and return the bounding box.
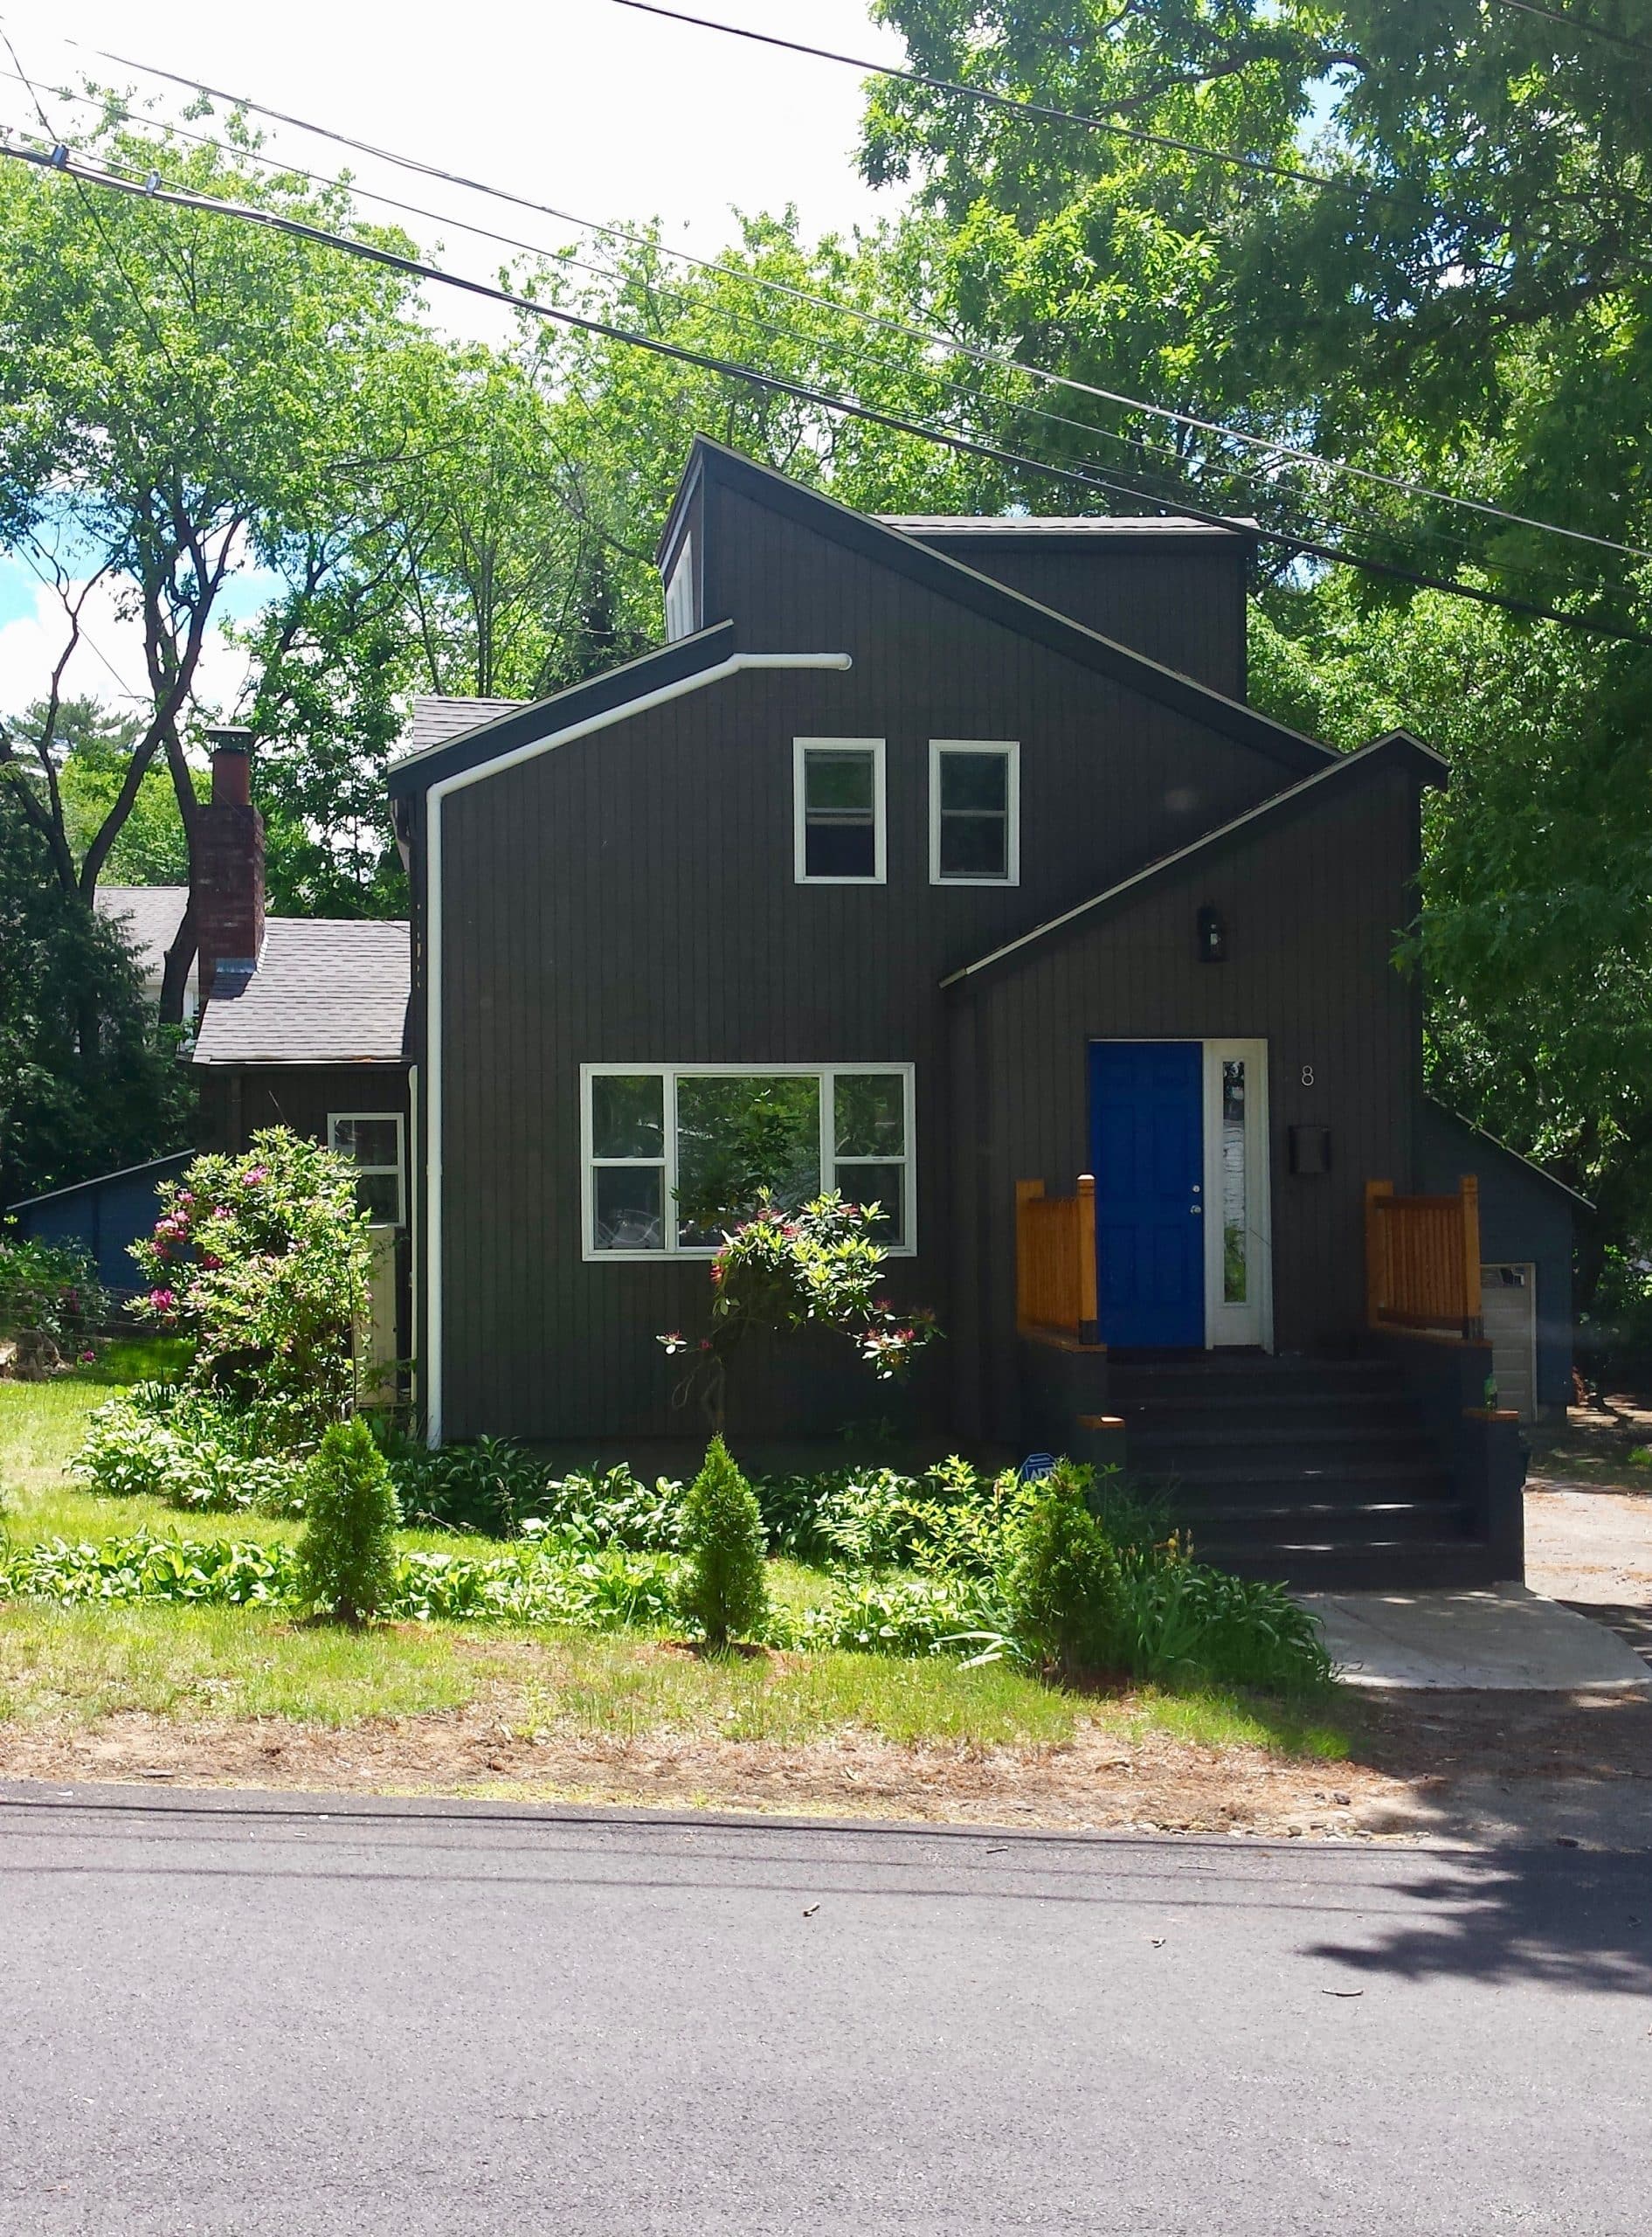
[0,105,433,1018]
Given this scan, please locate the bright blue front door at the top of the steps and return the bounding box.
[1091,1040,1205,1349]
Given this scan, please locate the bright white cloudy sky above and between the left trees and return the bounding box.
[0,0,903,711]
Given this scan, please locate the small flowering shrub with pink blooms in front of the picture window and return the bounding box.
[660,1190,941,1431]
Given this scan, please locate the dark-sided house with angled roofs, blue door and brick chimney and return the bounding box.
[83,440,1563,1582]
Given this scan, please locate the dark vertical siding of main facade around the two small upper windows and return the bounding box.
[429,488,1397,1438]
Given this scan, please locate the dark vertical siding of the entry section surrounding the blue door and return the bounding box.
[972,774,1421,1437]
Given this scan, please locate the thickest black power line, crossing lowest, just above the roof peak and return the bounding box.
[0,145,1652,651]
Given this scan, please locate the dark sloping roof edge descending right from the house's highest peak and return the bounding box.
[657,434,1341,776]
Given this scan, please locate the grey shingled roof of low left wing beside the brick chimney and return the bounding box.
[195,918,411,1065]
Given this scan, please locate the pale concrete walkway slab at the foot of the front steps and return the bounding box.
[1296,1583,1652,1693]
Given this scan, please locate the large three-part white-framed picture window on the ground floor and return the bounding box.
[581,1065,916,1257]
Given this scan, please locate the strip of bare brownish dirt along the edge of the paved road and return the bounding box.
[0,1686,1652,1846]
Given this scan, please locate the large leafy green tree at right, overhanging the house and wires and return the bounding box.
[863,0,1652,1302]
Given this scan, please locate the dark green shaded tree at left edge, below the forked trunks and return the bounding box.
[0,783,190,1206]
